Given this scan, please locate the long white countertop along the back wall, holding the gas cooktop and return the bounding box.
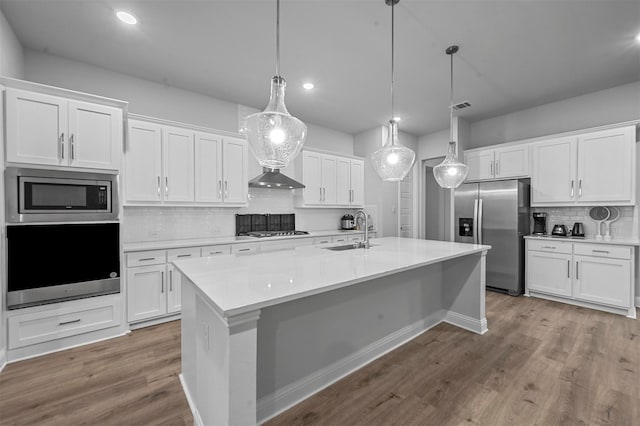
[122,229,375,253]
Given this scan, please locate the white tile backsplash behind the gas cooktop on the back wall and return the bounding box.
[122,188,353,243]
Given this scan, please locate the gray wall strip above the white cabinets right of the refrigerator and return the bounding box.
[469,81,640,148]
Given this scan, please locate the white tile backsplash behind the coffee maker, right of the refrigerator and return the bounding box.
[532,207,637,240]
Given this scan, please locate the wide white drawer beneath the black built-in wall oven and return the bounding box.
[9,298,121,349]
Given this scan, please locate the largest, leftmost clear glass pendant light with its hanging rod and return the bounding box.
[242,0,307,169]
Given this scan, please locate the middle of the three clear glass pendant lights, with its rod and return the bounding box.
[371,0,416,182]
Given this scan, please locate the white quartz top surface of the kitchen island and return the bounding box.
[174,237,491,317]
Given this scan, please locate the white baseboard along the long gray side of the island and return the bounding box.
[256,311,444,423]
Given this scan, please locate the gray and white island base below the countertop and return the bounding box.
[181,243,487,425]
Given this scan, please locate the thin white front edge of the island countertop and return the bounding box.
[173,245,491,319]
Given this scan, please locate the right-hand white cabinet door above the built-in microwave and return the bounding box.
[69,101,122,170]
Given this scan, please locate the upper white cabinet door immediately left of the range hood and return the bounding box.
[222,137,249,204]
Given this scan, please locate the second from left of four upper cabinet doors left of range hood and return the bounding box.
[162,127,195,201]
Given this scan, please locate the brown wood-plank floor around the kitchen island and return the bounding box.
[0,293,640,426]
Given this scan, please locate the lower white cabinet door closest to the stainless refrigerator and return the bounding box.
[527,250,572,297]
